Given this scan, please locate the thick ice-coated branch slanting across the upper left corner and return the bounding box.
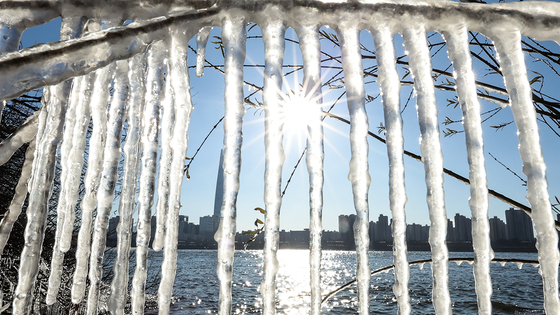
[0,7,218,101]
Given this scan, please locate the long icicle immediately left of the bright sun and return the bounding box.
[260,10,286,315]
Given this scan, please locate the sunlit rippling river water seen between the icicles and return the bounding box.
[142,250,544,315]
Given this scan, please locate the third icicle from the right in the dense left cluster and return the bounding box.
[130,41,166,314]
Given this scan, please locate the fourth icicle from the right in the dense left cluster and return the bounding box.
[108,56,143,314]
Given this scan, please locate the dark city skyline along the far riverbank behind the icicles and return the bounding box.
[107,208,535,251]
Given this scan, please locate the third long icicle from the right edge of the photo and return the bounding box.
[404,25,451,314]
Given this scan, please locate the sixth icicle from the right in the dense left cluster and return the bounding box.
[72,64,114,304]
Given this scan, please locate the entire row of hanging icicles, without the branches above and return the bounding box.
[0,2,560,315]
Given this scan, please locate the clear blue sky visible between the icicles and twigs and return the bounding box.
[19,1,560,230]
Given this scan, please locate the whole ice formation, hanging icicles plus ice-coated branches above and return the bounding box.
[0,0,560,314]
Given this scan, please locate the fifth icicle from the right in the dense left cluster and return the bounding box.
[87,60,128,315]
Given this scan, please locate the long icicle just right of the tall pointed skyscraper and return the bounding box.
[215,15,246,315]
